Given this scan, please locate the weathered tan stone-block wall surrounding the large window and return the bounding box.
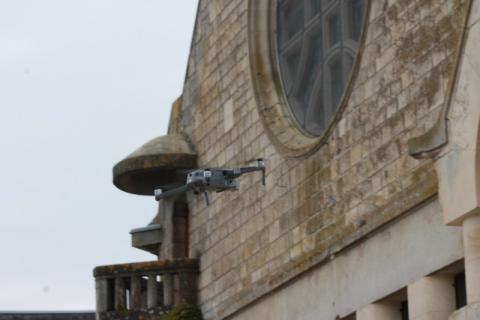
[176,0,468,319]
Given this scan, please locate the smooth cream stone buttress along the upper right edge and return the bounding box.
[435,1,480,225]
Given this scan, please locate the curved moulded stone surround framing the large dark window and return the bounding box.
[248,0,371,158]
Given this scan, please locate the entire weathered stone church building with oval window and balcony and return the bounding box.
[94,0,480,320]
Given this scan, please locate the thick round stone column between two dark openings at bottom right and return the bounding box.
[408,276,456,320]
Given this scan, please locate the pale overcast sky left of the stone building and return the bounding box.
[0,0,197,310]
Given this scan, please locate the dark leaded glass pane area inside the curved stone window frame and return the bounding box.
[276,0,365,136]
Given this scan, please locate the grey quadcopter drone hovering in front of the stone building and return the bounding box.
[154,159,265,205]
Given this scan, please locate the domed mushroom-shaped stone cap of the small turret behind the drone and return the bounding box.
[113,134,197,196]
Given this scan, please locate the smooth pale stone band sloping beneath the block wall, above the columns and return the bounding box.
[229,200,463,320]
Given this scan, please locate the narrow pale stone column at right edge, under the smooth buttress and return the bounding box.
[463,214,480,305]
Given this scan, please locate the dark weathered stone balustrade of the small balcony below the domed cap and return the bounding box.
[93,259,199,320]
